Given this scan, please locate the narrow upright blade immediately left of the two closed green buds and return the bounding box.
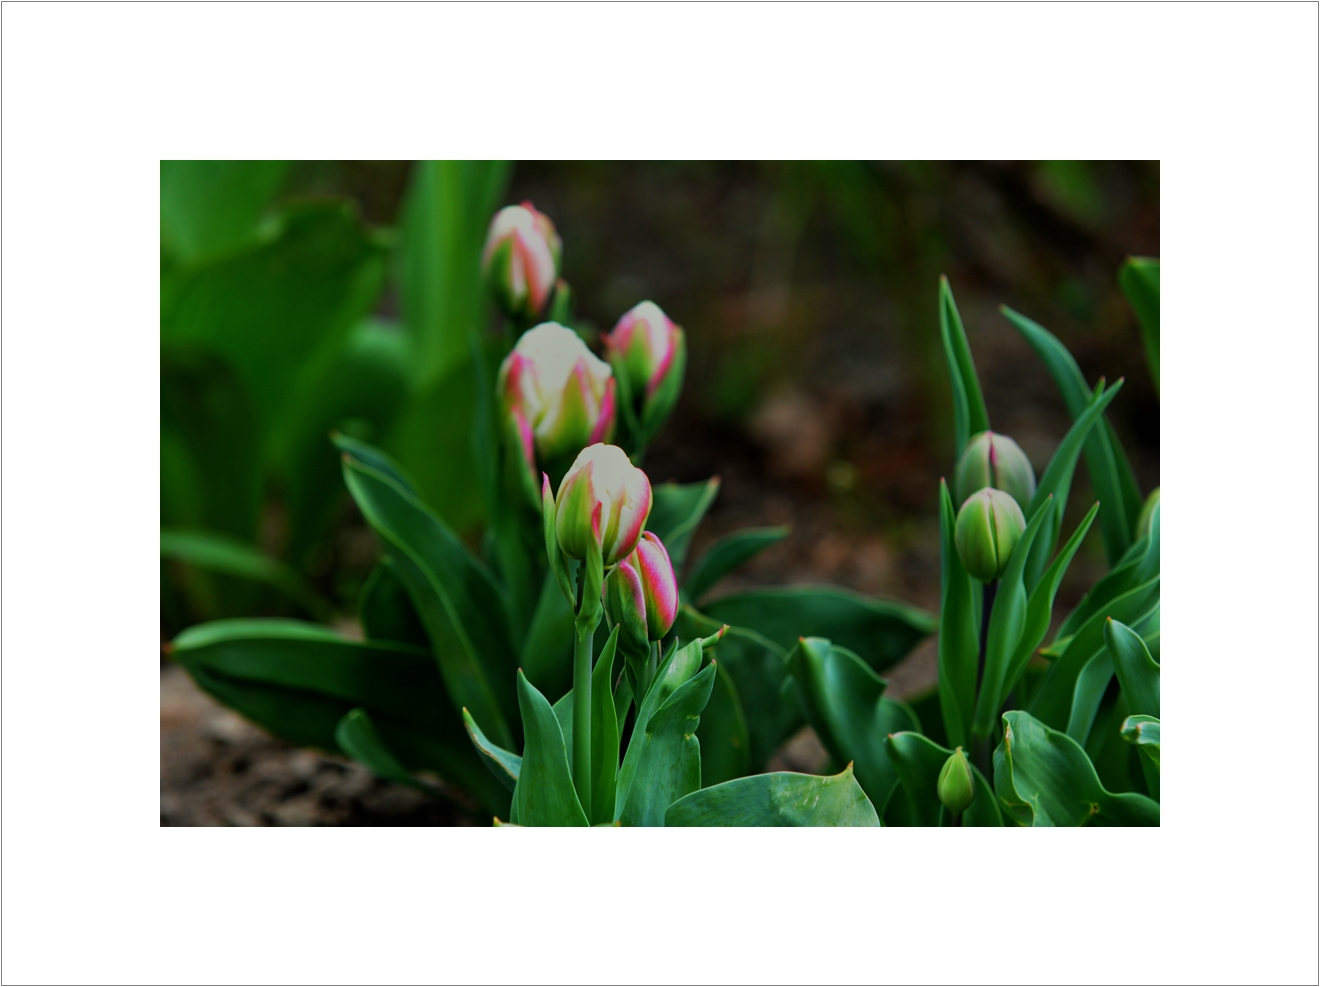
[939,478,981,747]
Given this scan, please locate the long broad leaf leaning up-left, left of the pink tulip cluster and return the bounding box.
[343,457,516,747]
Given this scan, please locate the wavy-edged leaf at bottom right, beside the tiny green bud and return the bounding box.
[994,710,1159,826]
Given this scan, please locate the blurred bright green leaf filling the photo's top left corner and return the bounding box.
[161,161,292,267]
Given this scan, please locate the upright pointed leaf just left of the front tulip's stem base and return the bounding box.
[513,672,587,826]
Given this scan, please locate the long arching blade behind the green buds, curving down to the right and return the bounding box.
[999,306,1140,565]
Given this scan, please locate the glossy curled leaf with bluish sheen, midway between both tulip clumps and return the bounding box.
[788,637,920,812]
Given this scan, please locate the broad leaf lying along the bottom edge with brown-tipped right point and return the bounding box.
[665,765,880,826]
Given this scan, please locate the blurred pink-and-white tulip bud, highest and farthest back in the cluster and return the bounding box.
[482,202,564,325]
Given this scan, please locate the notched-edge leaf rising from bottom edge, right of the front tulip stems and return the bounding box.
[618,662,715,826]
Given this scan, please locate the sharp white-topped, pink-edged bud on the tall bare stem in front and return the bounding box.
[554,442,651,567]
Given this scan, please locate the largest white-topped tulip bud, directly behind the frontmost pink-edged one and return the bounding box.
[496,322,614,487]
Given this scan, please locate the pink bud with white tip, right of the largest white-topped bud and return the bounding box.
[605,302,688,429]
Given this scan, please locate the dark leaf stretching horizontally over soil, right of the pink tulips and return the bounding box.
[702,586,936,675]
